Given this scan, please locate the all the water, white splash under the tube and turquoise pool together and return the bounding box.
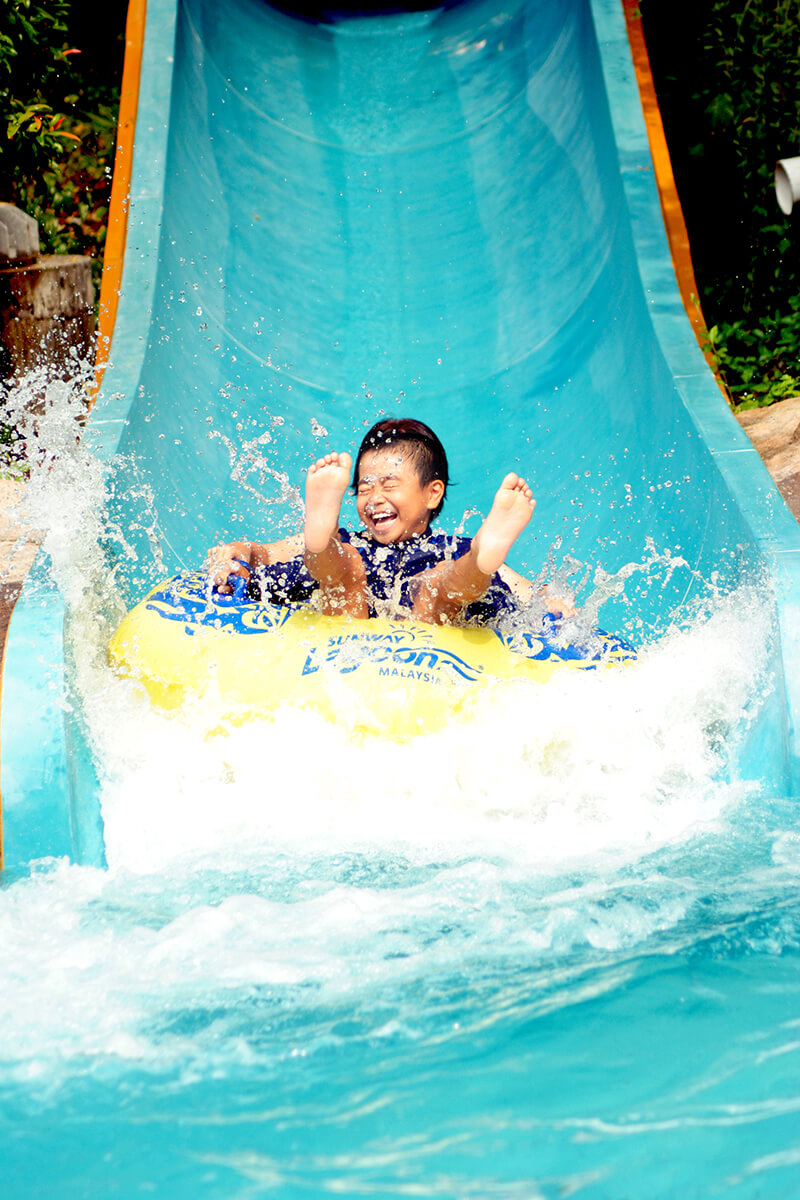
[0,376,800,1200]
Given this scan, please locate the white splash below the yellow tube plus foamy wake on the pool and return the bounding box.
[0,357,794,1088]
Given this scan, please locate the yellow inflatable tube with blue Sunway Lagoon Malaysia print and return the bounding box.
[109,572,636,740]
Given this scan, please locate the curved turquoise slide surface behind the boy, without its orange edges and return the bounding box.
[2,0,800,866]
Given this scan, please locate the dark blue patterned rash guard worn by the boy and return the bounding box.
[249,529,515,624]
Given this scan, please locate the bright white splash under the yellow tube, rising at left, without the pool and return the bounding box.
[1,357,771,871]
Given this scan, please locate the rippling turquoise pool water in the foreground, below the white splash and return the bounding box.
[0,799,800,1196]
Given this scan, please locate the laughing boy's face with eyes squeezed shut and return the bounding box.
[355,444,445,546]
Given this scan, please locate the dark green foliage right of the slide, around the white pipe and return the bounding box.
[642,0,800,407]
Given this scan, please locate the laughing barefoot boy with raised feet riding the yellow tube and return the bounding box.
[206,419,569,624]
